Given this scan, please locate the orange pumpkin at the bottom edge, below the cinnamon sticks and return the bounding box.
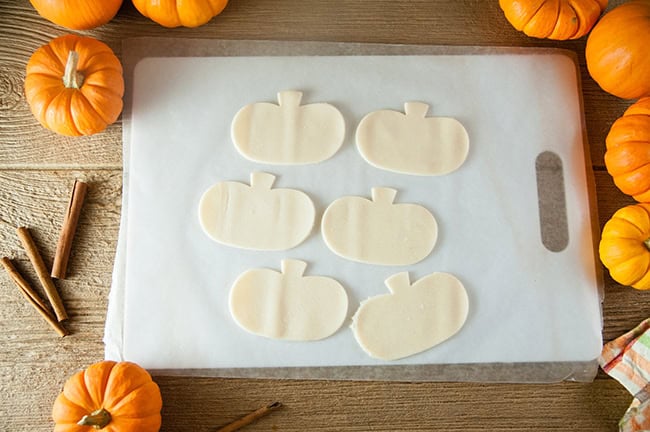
[52,360,162,432]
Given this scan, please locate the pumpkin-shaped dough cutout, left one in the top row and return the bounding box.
[231,91,345,165]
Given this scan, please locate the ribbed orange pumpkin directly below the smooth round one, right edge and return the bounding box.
[605,97,650,202]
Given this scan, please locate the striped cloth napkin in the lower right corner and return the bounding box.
[598,318,650,432]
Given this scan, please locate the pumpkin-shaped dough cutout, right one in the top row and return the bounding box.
[356,102,469,176]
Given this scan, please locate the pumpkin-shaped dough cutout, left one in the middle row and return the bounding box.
[199,172,316,250]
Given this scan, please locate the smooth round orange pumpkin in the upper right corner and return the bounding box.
[585,0,650,99]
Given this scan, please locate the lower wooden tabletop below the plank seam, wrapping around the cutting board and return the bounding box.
[0,170,646,431]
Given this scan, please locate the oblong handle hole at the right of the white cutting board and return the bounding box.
[535,151,569,252]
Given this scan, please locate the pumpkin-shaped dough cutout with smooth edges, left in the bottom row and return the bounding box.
[230,260,348,341]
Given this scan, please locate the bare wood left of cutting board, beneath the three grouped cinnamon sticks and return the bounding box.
[0,170,122,431]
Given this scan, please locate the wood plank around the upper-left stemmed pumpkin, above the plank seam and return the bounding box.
[0,0,121,168]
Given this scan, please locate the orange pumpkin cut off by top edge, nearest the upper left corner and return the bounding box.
[29,0,122,30]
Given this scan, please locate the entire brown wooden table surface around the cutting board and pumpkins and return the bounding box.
[0,0,649,432]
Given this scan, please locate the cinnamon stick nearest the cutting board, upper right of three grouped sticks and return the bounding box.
[51,180,88,279]
